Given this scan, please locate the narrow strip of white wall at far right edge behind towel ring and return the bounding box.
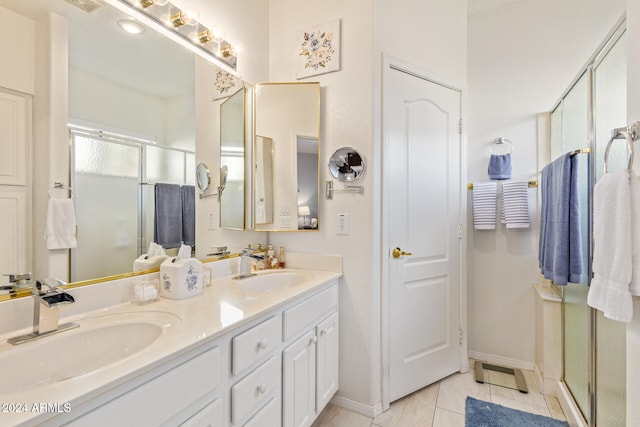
[627,0,640,426]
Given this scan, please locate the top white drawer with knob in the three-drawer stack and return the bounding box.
[231,317,280,375]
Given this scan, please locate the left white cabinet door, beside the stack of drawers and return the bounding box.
[282,330,317,427]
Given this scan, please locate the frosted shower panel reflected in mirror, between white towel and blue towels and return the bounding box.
[71,135,140,281]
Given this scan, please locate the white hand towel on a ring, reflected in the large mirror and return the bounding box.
[44,199,78,249]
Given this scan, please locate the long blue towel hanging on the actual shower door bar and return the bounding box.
[538,154,582,285]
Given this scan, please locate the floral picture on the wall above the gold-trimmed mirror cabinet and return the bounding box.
[296,19,340,79]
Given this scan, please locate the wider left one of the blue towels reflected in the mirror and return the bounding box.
[153,184,182,249]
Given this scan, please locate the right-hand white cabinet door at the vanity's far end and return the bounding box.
[316,313,338,412]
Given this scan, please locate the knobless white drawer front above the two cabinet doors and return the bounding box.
[283,285,338,340]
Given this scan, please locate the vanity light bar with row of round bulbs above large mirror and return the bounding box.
[103,0,240,77]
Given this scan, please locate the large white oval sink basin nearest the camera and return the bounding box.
[0,311,180,394]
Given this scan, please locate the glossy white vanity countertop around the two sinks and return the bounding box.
[0,256,341,425]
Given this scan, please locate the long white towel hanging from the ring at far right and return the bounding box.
[587,170,638,323]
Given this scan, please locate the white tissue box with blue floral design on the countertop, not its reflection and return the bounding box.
[160,257,202,299]
